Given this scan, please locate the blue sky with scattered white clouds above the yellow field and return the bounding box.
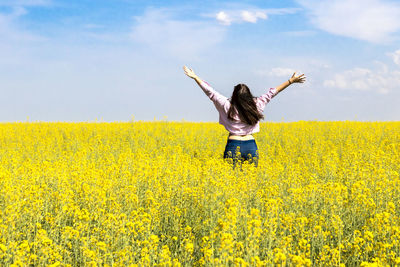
[0,0,400,121]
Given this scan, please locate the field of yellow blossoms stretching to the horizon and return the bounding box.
[0,121,400,266]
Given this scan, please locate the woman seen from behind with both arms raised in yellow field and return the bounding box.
[183,66,306,168]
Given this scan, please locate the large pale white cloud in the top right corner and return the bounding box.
[297,0,400,43]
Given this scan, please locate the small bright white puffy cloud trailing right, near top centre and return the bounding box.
[214,8,298,25]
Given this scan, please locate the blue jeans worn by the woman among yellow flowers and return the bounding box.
[224,139,258,168]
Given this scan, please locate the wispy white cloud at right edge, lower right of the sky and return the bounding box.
[323,62,400,94]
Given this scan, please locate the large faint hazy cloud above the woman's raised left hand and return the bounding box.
[131,9,226,59]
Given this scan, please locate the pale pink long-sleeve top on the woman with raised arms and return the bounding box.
[200,81,277,135]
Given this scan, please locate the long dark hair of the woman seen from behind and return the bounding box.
[228,83,264,125]
